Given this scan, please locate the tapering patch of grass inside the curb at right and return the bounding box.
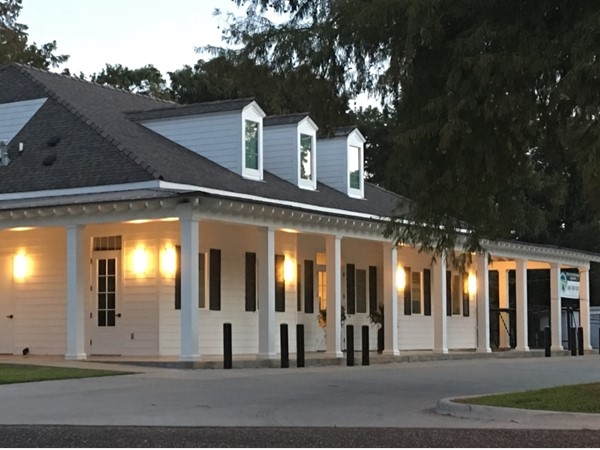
[460,383,600,414]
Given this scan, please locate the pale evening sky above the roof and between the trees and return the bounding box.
[19,0,244,76]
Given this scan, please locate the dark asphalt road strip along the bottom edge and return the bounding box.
[0,426,600,448]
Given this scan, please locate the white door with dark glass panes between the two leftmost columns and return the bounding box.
[90,251,123,355]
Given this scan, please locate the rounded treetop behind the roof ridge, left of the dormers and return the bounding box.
[90,64,170,99]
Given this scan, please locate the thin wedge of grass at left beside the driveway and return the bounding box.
[0,364,132,384]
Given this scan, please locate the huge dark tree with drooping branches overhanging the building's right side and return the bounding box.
[225,0,600,264]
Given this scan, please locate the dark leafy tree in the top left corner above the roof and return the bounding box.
[0,0,69,69]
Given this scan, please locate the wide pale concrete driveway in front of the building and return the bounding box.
[0,355,600,428]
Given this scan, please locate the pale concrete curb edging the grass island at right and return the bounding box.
[434,395,600,430]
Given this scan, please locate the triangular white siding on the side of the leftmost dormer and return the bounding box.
[143,111,243,174]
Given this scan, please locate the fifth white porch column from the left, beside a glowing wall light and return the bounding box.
[383,242,404,355]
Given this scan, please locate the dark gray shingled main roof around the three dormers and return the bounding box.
[0,64,408,216]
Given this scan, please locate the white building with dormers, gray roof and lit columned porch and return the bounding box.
[0,65,600,361]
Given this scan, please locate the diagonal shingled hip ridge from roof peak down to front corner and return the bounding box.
[13,63,163,179]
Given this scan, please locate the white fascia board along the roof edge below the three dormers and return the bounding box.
[160,181,389,220]
